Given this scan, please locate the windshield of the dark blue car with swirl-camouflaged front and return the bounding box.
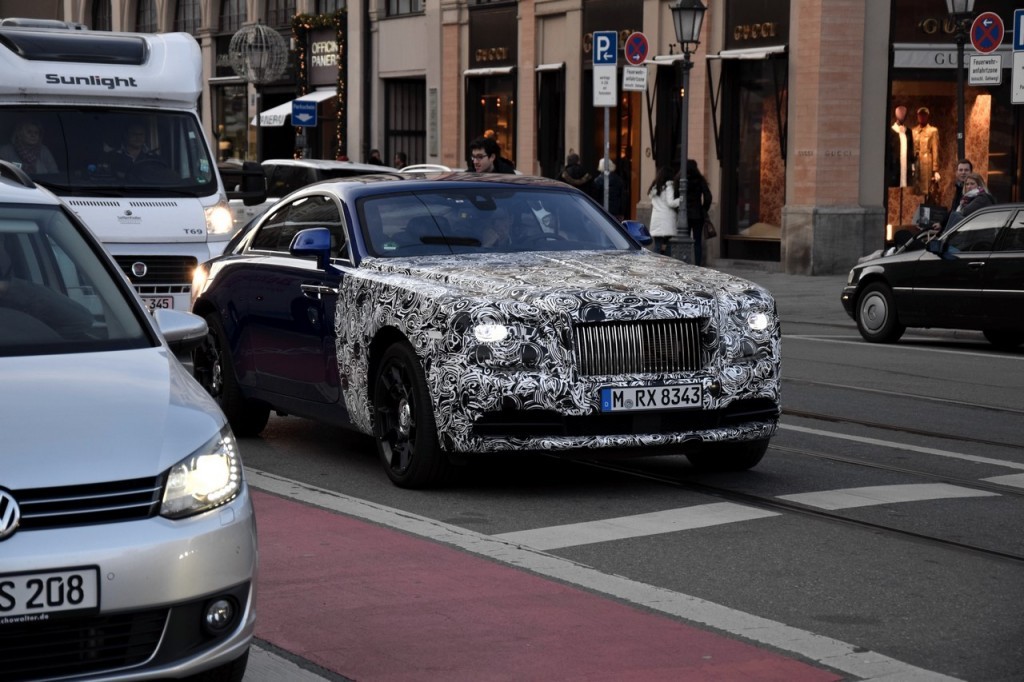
[357,185,636,258]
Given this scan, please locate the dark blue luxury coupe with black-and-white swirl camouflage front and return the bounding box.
[193,173,779,487]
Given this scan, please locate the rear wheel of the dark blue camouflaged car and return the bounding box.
[193,312,270,437]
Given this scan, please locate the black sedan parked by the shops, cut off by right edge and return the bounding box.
[842,204,1024,349]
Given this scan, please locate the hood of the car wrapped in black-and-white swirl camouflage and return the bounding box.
[365,251,771,316]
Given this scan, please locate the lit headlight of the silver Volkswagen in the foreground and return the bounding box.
[160,425,242,518]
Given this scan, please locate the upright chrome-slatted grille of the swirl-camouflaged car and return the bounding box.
[573,319,705,376]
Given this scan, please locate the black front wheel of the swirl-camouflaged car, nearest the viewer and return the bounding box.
[372,343,449,488]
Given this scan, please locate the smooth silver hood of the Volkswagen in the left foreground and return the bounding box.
[0,347,224,488]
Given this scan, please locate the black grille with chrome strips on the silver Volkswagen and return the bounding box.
[12,476,164,528]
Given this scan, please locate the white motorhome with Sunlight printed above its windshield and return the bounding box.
[0,25,262,310]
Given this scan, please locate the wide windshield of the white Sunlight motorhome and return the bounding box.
[0,106,217,197]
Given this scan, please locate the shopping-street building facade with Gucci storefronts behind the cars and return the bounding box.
[32,0,1024,274]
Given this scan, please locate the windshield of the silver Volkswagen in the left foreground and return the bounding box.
[0,204,155,356]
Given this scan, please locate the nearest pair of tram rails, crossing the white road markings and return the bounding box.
[573,445,1024,565]
